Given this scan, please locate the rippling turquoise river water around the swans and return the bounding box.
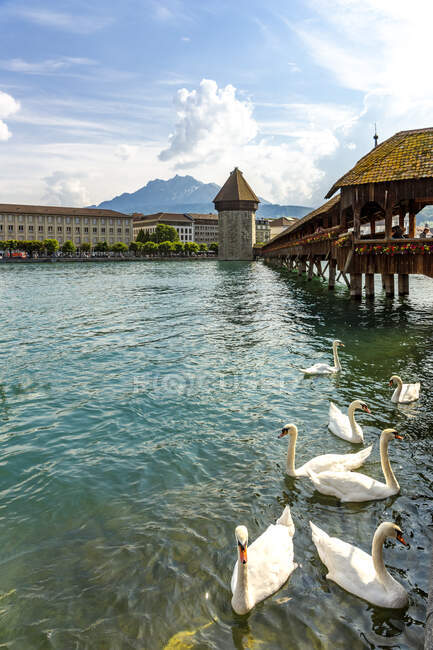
[0,261,433,650]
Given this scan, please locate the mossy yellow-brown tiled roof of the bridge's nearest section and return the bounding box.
[326,128,433,198]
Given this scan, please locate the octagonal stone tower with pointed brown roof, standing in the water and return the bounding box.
[213,167,260,260]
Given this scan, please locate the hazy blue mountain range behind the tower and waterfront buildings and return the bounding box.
[90,175,312,218]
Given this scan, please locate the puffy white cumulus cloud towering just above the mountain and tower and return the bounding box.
[159,79,258,166]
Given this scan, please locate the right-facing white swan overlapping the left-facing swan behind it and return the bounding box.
[307,429,403,502]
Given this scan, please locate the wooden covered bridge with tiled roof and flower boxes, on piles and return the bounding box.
[260,128,433,298]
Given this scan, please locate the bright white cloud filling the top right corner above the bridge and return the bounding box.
[297,0,433,129]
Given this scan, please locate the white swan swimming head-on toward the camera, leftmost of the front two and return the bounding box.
[231,506,297,614]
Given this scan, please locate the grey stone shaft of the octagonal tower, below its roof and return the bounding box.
[218,210,256,260]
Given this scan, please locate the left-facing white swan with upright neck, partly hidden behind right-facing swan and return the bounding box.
[278,424,373,477]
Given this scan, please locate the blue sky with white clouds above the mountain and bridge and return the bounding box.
[0,0,433,207]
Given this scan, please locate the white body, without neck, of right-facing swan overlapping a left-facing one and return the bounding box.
[308,471,392,502]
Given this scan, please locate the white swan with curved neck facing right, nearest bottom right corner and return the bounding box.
[310,521,408,607]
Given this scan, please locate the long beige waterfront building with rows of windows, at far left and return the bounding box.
[0,203,132,248]
